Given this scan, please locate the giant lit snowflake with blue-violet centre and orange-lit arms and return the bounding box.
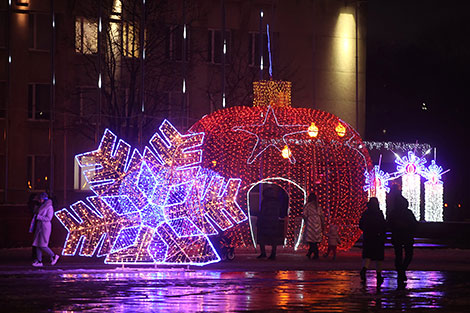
[56,120,247,265]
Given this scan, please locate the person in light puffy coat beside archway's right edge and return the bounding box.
[303,193,325,259]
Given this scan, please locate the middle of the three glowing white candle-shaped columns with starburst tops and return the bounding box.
[395,151,426,220]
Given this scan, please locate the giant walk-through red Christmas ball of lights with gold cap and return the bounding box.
[189,81,372,250]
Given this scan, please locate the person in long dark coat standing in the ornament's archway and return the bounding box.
[257,187,284,260]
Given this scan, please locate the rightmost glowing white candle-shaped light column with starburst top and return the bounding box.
[423,160,448,222]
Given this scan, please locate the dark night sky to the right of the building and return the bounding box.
[366,0,470,210]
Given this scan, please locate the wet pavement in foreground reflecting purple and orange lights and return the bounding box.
[0,267,470,313]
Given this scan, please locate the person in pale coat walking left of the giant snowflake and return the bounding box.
[32,192,59,267]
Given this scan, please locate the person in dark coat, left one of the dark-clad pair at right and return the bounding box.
[359,197,387,286]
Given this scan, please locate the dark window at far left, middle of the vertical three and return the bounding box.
[28,84,51,120]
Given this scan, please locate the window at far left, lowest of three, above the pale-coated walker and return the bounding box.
[26,155,50,190]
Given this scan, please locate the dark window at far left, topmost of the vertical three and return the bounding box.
[29,14,52,50]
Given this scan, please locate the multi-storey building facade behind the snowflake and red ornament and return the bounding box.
[0,0,366,206]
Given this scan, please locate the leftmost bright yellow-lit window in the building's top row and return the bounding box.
[75,17,98,54]
